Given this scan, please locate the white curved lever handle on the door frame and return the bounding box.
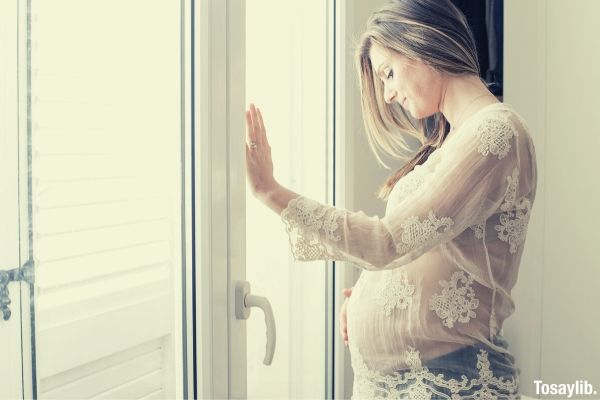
[235,281,277,365]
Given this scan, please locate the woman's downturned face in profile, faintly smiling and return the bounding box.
[369,43,442,119]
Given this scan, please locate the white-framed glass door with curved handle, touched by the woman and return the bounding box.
[197,0,335,399]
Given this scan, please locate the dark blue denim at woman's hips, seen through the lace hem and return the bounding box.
[384,334,521,400]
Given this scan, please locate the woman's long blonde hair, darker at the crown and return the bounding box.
[355,0,488,200]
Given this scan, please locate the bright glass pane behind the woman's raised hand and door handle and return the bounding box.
[245,0,333,399]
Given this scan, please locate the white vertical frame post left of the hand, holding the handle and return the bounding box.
[193,0,246,398]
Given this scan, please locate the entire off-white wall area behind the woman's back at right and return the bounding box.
[505,0,600,394]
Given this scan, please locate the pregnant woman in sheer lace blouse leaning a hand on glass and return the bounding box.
[246,0,537,400]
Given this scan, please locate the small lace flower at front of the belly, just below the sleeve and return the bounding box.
[377,270,415,317]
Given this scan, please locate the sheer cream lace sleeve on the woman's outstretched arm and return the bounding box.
[281,113,531,270]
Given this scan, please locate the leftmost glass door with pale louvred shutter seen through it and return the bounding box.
[0,0,191,399]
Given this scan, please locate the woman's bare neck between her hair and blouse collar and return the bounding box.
[439,75,498,131]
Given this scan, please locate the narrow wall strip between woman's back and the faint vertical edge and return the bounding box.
[504,0,558,395]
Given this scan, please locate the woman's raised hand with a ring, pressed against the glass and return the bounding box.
[246,104,278,197]
